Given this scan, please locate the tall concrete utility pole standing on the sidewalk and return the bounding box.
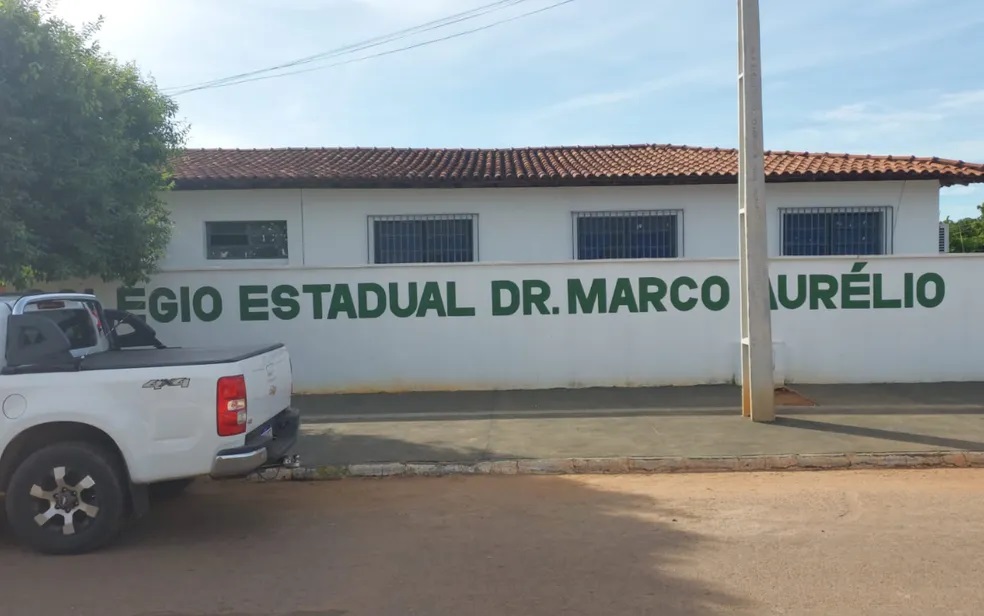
[738,0,776,421]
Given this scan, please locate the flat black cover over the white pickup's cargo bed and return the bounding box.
[79,342,284,371]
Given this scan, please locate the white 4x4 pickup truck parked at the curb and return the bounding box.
[0,293,300,554]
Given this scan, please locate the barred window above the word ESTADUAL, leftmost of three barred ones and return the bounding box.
[369,214,478,264]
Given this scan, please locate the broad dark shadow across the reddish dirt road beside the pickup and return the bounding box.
[0,436,752,616]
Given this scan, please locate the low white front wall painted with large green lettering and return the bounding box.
[53,254,984,393]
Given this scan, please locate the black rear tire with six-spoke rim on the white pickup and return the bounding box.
[6,442,126,554]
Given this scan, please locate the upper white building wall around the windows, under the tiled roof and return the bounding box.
[161,176,939,270]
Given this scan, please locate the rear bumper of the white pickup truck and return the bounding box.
[209,408,301,479]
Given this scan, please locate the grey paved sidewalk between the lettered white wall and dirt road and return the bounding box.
[295,382,984,466]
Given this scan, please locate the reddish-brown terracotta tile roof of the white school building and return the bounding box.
[174,144,984,189]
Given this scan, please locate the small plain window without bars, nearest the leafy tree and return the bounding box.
[205,220,288,259]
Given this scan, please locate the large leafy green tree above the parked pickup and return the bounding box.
[0,0,185,287]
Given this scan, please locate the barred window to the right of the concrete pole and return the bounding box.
[779,206,892,256]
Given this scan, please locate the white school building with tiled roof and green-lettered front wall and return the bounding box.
[57,145,984,393]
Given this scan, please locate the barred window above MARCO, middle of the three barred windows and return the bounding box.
[574,210,683,260]
